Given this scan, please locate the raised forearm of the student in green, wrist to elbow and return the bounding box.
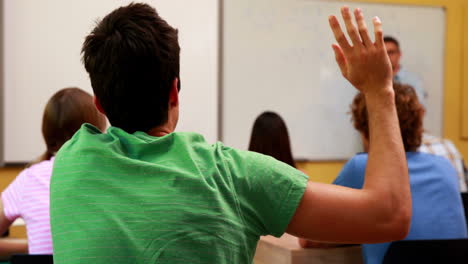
[364,86,411,231]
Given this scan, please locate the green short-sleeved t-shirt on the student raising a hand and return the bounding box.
[50,124,307,264]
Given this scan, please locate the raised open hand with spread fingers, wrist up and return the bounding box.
[329,6,392,94]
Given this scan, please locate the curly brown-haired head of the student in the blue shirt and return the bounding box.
[351,83,424,151]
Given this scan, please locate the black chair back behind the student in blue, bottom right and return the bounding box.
[383,239,468,264]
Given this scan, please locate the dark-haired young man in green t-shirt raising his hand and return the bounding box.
[51,4,411,264]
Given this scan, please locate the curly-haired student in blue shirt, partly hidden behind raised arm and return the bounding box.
[324,84,467,264]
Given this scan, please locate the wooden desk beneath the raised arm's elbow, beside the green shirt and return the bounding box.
[254,234,363,264]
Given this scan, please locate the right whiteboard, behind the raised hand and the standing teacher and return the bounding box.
[221,0,445,160]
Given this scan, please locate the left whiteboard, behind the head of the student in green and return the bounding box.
[3,0,219,163]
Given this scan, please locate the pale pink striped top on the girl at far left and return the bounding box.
[2,158,54,254]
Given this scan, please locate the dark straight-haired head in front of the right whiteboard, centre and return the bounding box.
[249,112,296,167]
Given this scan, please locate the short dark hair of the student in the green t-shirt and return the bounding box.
[82,3,180,133]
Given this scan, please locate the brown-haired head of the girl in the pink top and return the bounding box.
[39,88,106,161]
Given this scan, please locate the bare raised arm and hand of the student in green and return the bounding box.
[287,7,411,243]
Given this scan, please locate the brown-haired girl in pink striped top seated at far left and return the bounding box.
[0,88,106,257]
